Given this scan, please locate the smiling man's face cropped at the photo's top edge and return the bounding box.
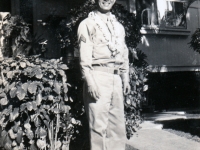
[97,0,116,12]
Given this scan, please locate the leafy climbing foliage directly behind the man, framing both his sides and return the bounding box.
[57,0,148,138]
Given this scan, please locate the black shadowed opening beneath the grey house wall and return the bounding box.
[148,72,200,111]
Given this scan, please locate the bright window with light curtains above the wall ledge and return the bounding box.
[137,0,187,28]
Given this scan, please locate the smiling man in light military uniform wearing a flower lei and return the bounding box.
[78,0,130,150]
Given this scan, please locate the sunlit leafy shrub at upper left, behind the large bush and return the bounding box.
[2,15,32,57]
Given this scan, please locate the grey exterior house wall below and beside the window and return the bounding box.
[138,1,200,71]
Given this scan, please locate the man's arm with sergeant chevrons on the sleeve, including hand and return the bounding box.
[78,21,99,100]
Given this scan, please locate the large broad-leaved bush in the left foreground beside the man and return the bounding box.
[0,55,81,150]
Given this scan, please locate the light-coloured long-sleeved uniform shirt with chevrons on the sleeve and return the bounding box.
[78,11,129,85]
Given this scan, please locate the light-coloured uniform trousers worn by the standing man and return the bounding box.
[83,71,126,150]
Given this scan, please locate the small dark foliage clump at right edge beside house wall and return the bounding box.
[189,28,200,53]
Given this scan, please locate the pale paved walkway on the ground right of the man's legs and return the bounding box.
[127,112,200,150]
